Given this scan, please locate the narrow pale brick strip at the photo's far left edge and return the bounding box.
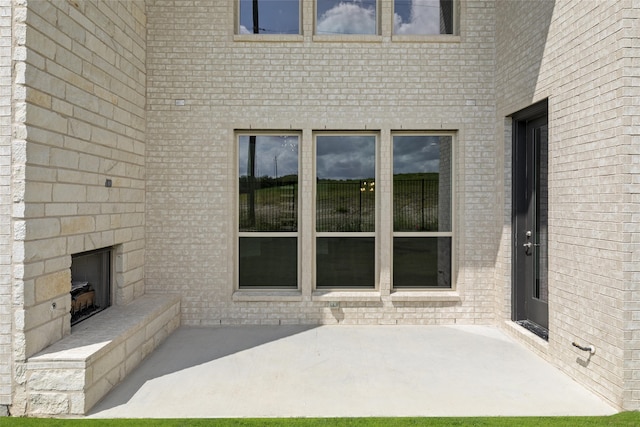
[0,0,12,416]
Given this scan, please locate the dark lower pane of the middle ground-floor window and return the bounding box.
[316,237,375,288]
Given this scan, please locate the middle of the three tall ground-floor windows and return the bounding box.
[316,134,376,289]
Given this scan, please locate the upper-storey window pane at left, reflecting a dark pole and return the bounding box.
[238,0,300,34]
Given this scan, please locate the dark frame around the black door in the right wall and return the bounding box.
[511,99,548,339]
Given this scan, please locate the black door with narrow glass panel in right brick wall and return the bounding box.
[513,103,549,339]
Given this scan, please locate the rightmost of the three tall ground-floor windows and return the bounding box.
[393,134,453,288]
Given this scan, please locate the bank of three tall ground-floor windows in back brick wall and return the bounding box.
[236,131,455,290]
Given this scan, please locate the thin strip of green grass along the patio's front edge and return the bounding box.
[0,418,640,427]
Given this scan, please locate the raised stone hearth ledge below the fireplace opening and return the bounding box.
[26,294,180,416]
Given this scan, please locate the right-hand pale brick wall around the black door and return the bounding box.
[496,0,640,410]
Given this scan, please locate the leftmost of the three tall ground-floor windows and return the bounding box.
[238,134,298,289]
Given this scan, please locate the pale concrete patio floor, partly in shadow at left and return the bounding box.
[89,326,616,418]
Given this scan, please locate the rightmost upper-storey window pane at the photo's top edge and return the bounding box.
[393,0,453,34]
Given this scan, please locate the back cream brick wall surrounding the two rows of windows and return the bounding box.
[145,0,498,325]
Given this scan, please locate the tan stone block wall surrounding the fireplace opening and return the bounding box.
[10,0,146,414]
